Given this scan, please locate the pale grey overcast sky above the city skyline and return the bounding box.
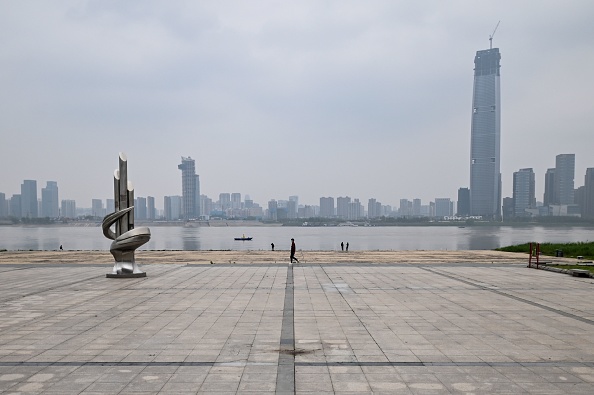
[0,0,594,207]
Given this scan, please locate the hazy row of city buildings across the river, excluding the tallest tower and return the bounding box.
[0,154,594,219]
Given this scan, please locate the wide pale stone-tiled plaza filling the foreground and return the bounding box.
[0,263,594,395]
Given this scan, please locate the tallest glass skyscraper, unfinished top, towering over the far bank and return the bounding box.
[470,48,501,219]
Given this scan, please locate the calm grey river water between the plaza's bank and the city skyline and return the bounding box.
[0,226,594,250]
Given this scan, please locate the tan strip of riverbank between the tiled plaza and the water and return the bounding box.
[0,250,575,265]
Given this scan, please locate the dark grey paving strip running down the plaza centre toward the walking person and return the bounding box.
[276,263,295,394]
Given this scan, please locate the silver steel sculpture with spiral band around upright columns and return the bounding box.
[102,152,151,278]
